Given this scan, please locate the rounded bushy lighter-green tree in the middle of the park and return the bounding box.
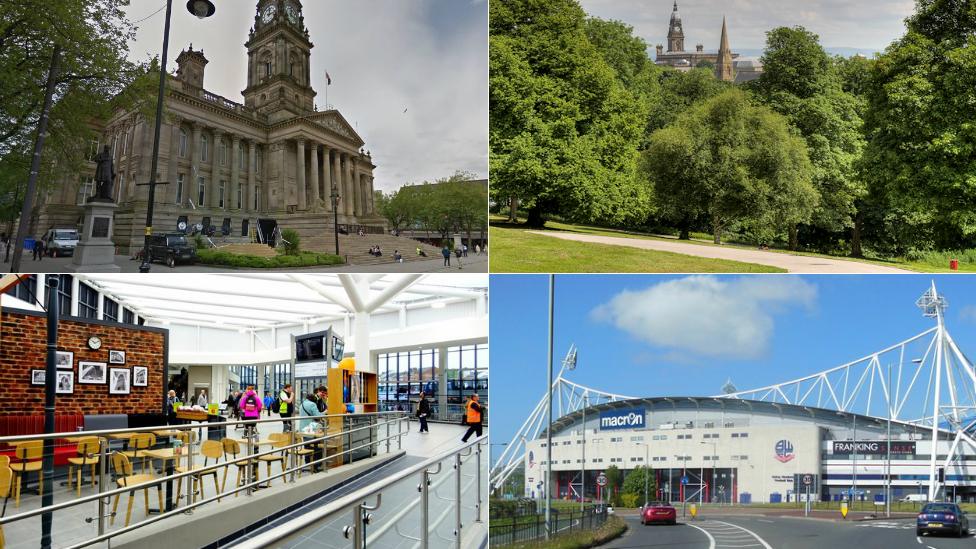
[644,89,817,243]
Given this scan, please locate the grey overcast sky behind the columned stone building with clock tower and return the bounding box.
[127,0,488,192]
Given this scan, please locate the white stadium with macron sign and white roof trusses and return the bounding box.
[491,283,976,503]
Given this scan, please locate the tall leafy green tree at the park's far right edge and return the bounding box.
[864,0,976,253]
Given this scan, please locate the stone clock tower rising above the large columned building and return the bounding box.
[242,0,316,122]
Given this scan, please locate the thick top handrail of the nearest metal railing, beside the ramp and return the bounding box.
[230,435,488,549]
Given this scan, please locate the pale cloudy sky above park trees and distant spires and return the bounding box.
[580,0,915,56]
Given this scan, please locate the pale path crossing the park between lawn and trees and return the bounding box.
[529,231,912,274]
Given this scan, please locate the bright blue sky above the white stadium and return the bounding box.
[489,275,976,457]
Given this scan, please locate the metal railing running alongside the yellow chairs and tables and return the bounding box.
[0,412,409,549]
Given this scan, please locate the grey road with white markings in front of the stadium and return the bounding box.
[603,512,976,549]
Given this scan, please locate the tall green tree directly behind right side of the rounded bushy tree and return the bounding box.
[756,27,865,251]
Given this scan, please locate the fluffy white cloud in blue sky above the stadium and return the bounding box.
[590,276,817,359]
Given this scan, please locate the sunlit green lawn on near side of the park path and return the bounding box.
[489,226,785,273]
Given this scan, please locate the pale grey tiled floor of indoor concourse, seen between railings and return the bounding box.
[3,423,487,549]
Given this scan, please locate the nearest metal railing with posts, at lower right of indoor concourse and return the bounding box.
[235,436,488,549]
